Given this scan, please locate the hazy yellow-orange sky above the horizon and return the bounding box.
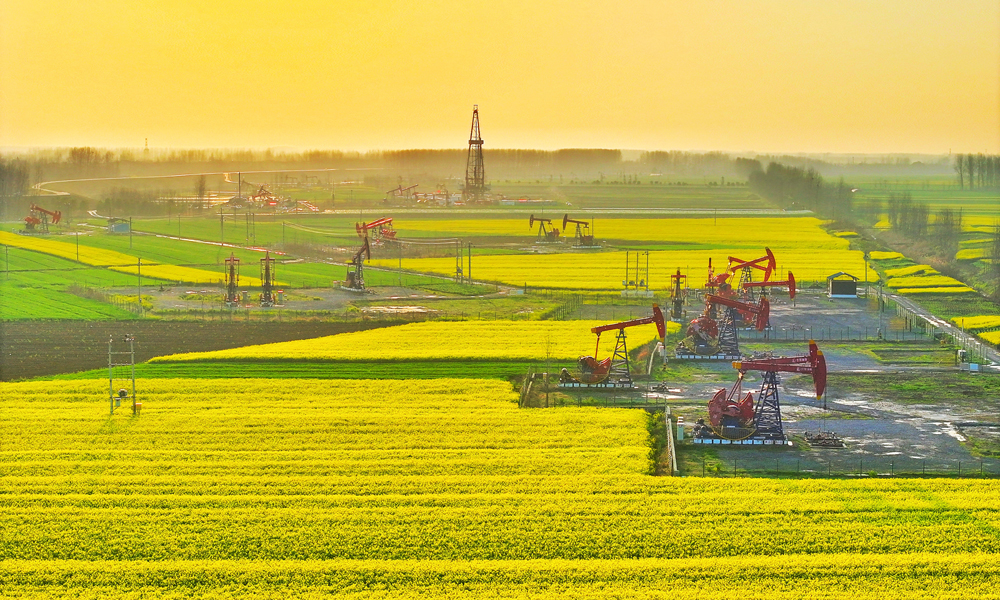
[0,0,1000,153]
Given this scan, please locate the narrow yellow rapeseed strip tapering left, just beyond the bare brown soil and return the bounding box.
[150,322,680,362]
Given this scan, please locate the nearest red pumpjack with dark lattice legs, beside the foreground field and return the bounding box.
[699,341,827,441]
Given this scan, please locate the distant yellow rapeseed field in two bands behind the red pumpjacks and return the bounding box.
[373,215,878,290]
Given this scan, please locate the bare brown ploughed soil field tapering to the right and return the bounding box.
[0,320,395,381]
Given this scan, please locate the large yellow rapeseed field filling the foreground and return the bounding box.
[0,379,1000,600]
